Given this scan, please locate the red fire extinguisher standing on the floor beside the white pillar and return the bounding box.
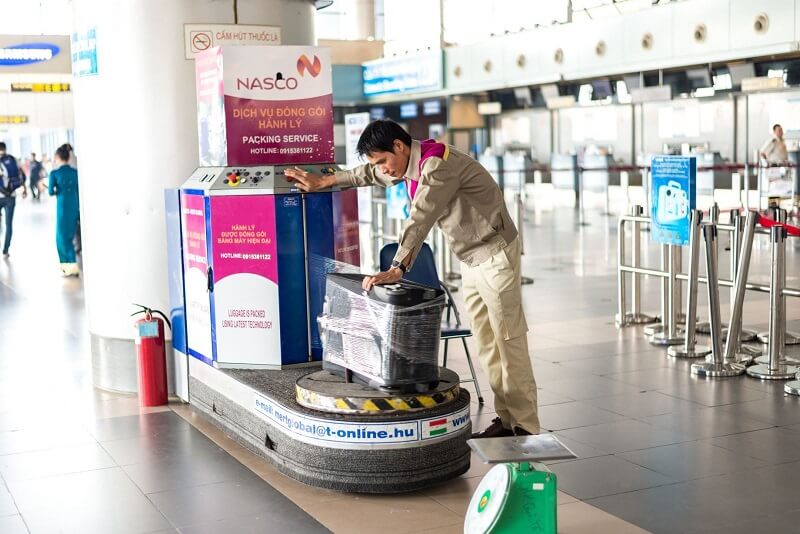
[131,304,172,406]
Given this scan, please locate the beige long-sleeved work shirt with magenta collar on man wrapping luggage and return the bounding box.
[335,141,517,268]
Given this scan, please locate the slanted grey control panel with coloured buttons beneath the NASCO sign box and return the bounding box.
[206,164,337,195]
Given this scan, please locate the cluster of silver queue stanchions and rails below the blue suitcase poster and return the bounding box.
[616,208,800,384]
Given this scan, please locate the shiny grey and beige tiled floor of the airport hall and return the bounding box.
[0,194,800,534]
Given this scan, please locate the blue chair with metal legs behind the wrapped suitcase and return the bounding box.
[380,243,483,406]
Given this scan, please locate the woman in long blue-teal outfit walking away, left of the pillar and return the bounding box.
[48,146,79,276]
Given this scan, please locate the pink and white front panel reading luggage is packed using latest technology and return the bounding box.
[211,195,281,367]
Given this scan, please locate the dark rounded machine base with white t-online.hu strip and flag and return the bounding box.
[190,359,472,493]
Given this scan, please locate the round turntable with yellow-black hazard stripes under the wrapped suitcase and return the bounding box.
[296,367,461,415]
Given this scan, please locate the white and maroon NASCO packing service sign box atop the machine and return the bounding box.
[196,46,334,166]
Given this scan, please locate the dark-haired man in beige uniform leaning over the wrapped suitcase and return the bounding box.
[286,120,539,437]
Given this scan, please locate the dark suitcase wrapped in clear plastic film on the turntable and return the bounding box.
[318,273,445,391]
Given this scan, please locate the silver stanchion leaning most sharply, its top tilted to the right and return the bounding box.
[725,211,758,365]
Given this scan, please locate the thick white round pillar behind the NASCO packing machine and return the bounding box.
[73,0,315,392]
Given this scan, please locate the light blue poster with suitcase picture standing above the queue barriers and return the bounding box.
[650,156,697,245]
